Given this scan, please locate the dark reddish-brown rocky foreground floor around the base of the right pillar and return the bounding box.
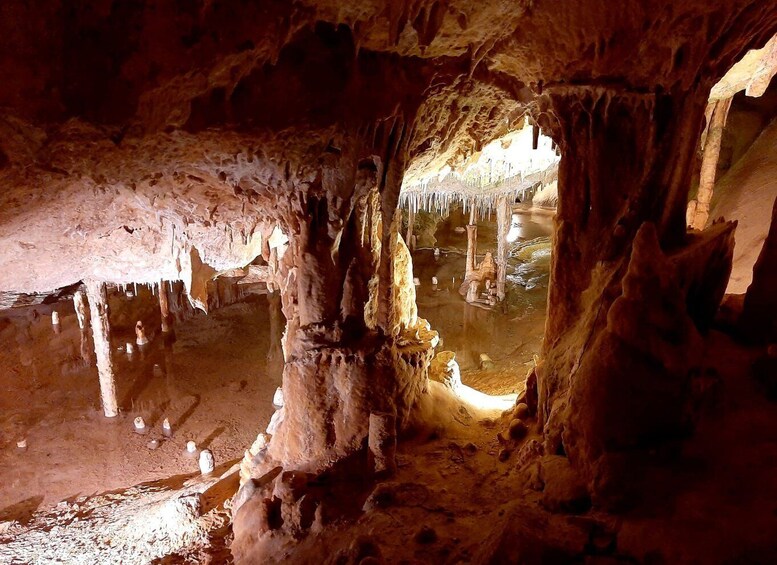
[235,332,777,565]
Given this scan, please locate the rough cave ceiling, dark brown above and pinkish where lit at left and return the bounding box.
[0,0,777,292]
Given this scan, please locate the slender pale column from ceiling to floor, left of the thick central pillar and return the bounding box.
[86,281,119,418]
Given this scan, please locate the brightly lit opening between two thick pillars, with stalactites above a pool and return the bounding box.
[400,122,558,397]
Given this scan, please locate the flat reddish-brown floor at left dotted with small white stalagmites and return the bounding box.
[0,297,281,521]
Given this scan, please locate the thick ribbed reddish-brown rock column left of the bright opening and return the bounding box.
[250,123,431,472]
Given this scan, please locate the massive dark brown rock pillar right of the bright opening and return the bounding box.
[537,85,734,505]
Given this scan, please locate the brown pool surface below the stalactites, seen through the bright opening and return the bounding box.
[412,205,553,395]
